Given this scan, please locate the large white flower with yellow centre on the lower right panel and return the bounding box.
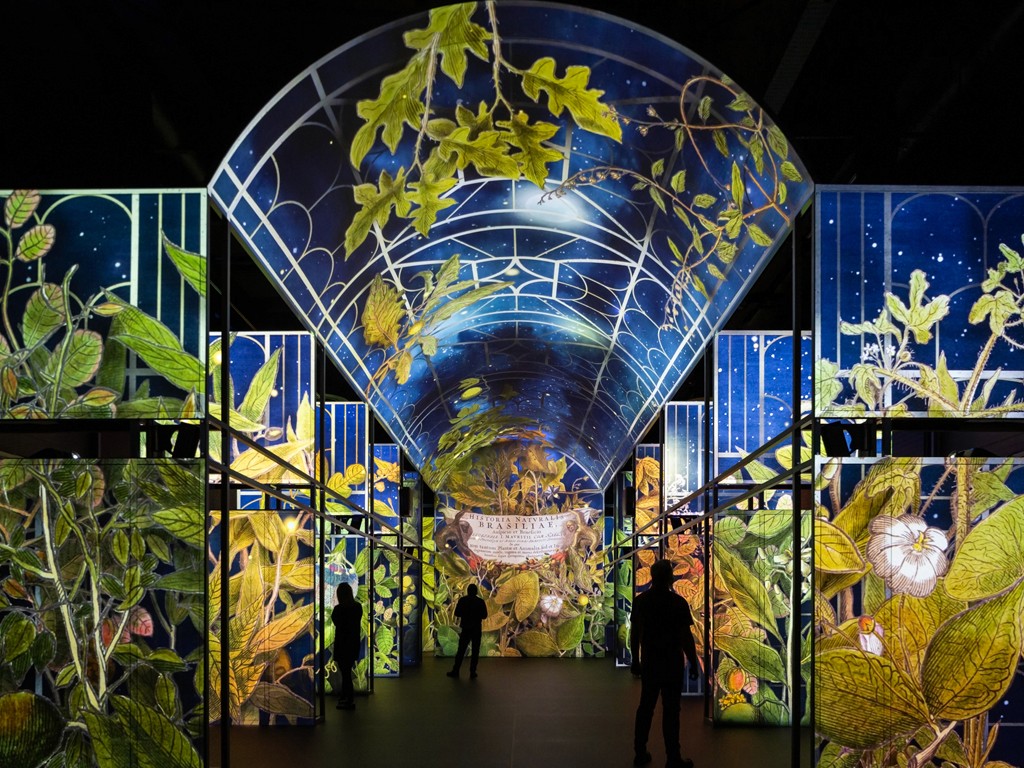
[867,515,949,597]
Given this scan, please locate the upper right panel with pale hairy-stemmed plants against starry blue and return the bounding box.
[815,187,1024,418]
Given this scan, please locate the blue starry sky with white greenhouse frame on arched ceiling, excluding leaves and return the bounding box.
[210,2,810,487]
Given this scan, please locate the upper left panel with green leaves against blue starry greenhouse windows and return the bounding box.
[0,189,207,419]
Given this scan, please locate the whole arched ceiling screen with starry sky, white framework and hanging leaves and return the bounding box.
[211,0,811,489]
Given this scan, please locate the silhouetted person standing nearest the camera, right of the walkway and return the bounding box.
[630,560,697,768]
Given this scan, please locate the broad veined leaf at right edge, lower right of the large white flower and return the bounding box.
[922,587,1024,720]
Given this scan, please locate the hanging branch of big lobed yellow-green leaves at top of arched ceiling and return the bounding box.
[345,1,622,257]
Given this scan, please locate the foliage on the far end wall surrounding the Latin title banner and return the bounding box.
[424,440,612,656]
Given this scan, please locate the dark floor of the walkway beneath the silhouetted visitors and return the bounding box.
[210,658,810,768]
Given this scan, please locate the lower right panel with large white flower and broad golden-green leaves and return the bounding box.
[814,458,1024,768]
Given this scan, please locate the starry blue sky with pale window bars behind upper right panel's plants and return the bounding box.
[815,186,1024,416]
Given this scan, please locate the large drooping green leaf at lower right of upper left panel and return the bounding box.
[109,304,206,393]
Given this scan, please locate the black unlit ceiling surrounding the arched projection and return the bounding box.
[0,0,1024,403]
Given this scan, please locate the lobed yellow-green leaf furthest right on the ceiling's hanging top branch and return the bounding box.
[522,56,623,141]
